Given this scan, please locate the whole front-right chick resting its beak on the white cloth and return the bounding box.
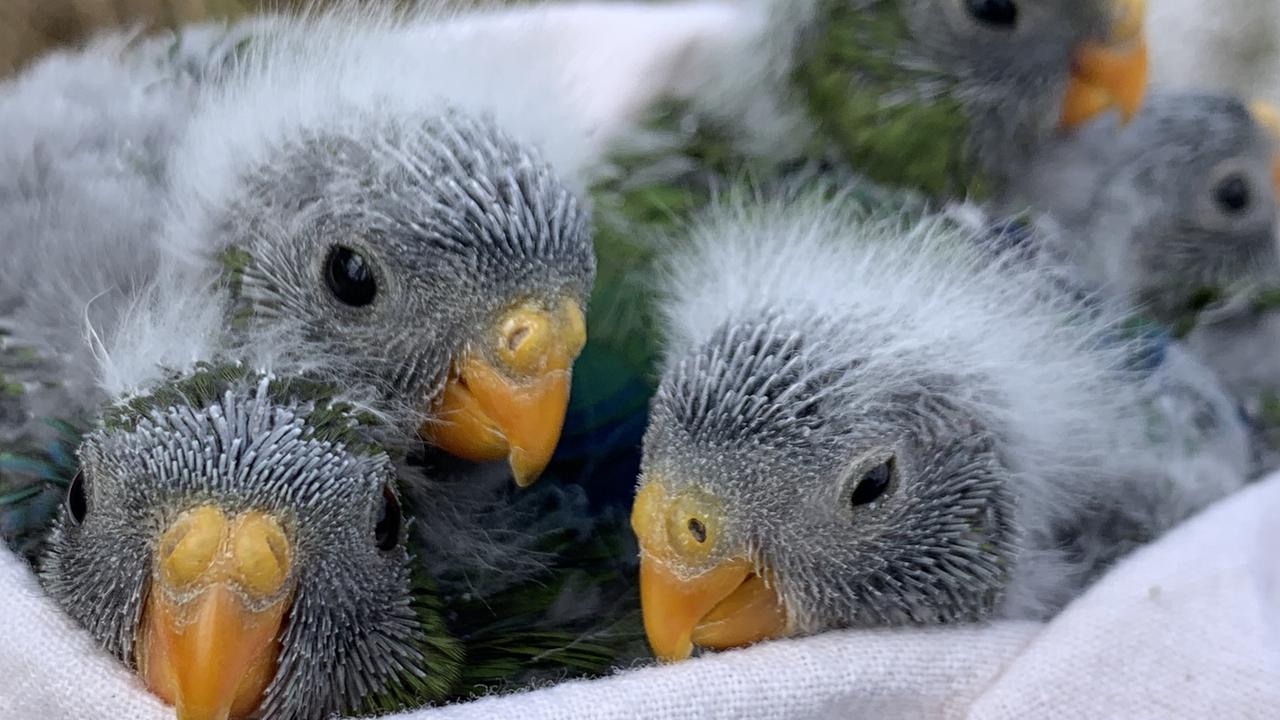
[632,189,1247,660]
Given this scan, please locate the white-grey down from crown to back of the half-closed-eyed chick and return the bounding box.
[663,197,1248,616]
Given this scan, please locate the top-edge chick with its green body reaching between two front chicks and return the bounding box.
[581,0,1146,476]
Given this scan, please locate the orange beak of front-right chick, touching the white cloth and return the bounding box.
[631,483,787,662]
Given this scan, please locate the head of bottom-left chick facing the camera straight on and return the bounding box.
[42,368,453,720]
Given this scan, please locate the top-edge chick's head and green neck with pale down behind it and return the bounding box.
[650,0,1147,197]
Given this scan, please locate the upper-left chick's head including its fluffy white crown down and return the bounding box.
[166,8,595,486]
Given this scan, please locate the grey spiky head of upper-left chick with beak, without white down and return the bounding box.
[219,113,595,486]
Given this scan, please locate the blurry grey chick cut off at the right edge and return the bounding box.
[1002,92,1280,326]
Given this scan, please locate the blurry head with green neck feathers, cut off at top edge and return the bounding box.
[788,0,1147,195]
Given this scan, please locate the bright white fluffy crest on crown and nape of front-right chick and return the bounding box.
[666,193,1134,481]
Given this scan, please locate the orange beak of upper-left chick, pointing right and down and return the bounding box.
[419,294,586,487]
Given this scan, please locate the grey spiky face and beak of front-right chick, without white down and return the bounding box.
[631,311,1012,660]
